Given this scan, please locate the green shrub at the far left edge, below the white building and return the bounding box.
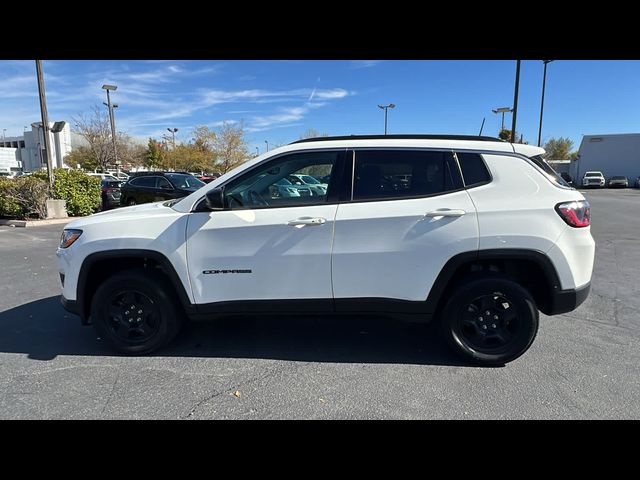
[0,176,49,218]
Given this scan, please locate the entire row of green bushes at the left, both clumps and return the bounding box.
[0,168,101,221]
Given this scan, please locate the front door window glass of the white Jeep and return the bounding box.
[225,152,339,210]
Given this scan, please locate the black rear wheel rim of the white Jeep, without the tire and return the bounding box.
[458,293,519,352]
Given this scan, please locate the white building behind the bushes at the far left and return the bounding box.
[0,122,71,172]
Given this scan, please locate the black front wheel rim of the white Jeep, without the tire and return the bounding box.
[106,291,160,343]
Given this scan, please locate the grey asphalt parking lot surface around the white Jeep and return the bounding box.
[0,189,640,419]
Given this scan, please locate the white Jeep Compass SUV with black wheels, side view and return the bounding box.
[57,135,595,365]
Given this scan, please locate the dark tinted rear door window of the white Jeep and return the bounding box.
[353,150,460,200]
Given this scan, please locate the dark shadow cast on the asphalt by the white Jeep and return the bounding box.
[0,296,465,366]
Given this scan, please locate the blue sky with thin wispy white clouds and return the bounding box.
[0,60,640,152]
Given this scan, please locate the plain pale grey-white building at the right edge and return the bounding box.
[570,133,640,184]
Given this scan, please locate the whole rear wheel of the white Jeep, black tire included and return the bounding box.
[440,277,539,366]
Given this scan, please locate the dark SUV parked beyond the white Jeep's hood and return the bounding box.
[120,172,204,205]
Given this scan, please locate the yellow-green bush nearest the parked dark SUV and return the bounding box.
[51,168,102,217]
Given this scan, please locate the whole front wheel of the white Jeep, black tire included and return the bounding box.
[91,268,183,355]
